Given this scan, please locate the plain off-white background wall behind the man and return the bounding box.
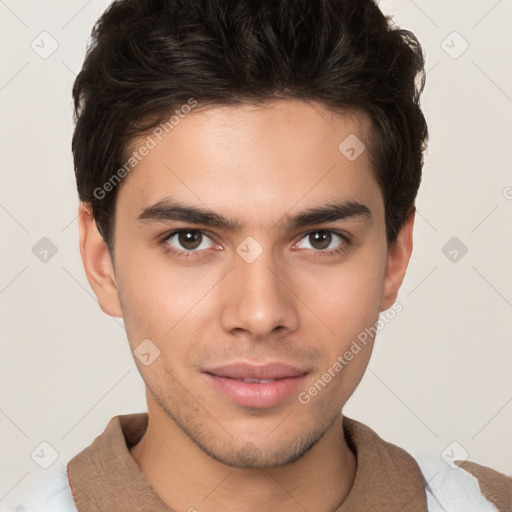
[0,0,512,507]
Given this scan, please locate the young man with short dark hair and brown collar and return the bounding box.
[8,0,512,512]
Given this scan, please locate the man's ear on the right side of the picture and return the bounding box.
[380,208,415,311]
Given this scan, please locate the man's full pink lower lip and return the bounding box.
[203,373,307,409]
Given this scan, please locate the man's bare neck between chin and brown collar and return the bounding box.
[130,394,356,512]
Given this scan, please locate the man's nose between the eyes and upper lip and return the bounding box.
[220,243,300,341]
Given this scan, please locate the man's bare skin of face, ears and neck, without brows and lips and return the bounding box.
[79,100,414,512]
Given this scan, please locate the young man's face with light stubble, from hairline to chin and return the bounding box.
[82,100,412,467]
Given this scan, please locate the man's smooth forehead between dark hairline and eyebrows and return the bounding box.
[116,100,383,227]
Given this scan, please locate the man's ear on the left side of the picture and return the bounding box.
[78,202,123,317]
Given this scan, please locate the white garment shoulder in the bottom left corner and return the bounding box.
[0,465,78,512]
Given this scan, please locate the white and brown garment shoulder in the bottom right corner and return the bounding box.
[415,455,512,512]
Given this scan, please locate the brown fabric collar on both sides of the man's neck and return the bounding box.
[67,413,427,512]
